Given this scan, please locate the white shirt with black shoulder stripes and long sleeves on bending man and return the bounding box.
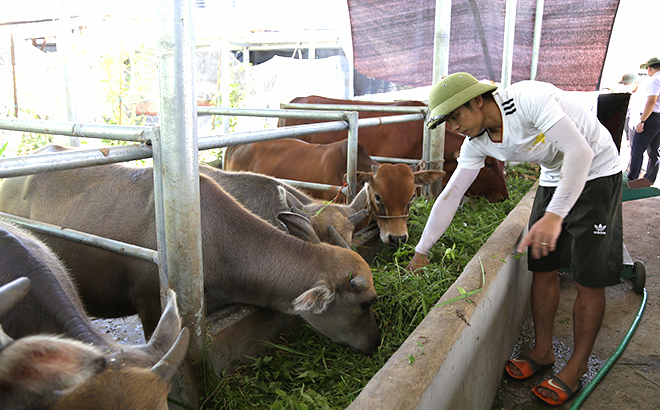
[415,81,621,254]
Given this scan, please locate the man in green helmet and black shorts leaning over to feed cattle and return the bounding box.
[407,73,623,406]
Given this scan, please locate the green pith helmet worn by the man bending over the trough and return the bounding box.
[426,73,497,129]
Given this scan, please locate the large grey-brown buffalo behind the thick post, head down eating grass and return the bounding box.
[0,146,380,354]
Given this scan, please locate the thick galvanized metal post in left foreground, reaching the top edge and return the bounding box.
[154,0,206,408]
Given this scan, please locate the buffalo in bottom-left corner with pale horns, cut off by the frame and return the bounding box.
[0,222,189,410]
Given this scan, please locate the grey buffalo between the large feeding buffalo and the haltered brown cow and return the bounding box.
[199,164,367,244]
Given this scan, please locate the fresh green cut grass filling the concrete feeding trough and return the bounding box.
[203,164,538,410]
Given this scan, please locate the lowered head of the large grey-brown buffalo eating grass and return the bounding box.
[291,244,380,355]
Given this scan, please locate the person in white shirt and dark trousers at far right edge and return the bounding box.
[628,57,660,188]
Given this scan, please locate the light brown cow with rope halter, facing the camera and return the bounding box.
[224,138,445,244]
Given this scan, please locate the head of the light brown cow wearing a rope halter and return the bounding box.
[358,164,445,245]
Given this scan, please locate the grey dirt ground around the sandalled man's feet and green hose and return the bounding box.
[492,140,660,410]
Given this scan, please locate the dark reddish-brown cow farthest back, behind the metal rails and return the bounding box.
[278,95,509,202]
